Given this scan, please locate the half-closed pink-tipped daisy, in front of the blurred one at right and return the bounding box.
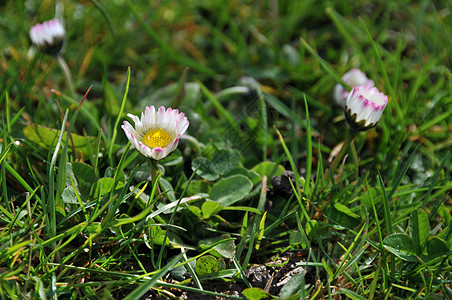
[345,85,388,131]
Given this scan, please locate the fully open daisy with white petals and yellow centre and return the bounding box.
[122,106,189,160]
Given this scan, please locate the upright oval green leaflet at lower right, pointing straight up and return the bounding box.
[409,209,430,254]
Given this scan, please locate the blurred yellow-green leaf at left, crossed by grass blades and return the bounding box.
[24,123,97,157]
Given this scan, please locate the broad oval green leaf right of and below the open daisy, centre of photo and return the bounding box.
[210,175,253,206]
